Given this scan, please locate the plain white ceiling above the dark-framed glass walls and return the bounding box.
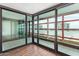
[0,3,58,14]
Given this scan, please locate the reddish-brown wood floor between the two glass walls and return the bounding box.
[0,44,58,56]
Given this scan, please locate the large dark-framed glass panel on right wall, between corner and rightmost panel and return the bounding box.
[38,10,55,49]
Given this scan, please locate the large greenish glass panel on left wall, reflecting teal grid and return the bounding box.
[2,9,26,51]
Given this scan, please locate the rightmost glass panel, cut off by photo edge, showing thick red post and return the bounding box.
[57,4,79,55]
